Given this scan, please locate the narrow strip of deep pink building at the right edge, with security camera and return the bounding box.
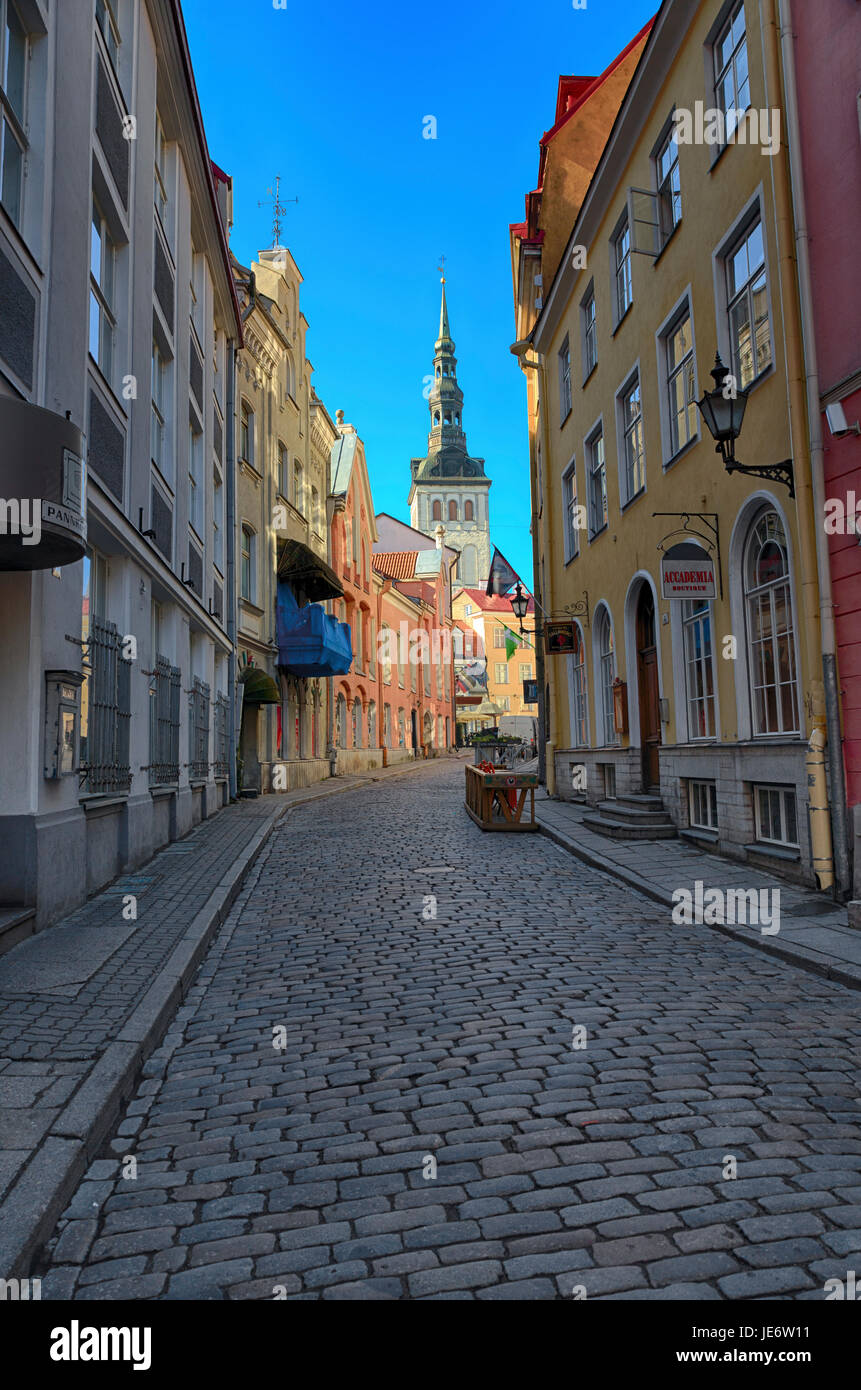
[780,0,861,895]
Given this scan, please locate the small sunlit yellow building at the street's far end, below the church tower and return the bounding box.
[452,589,538,724]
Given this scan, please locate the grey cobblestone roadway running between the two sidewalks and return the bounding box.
[36,763,861,1300]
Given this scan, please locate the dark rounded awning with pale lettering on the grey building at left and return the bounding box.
[0,396,86,570]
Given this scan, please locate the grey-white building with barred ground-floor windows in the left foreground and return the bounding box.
[0,0,241,951]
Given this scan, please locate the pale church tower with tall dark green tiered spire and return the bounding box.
[408,277,491,588]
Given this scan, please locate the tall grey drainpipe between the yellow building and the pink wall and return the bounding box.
[778,0,851,898]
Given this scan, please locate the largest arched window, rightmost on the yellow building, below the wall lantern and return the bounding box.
[744,512,798,734]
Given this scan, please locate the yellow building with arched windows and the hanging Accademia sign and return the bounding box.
[512,0,832,887]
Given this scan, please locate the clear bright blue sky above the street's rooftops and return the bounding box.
[184,0,658,582]
